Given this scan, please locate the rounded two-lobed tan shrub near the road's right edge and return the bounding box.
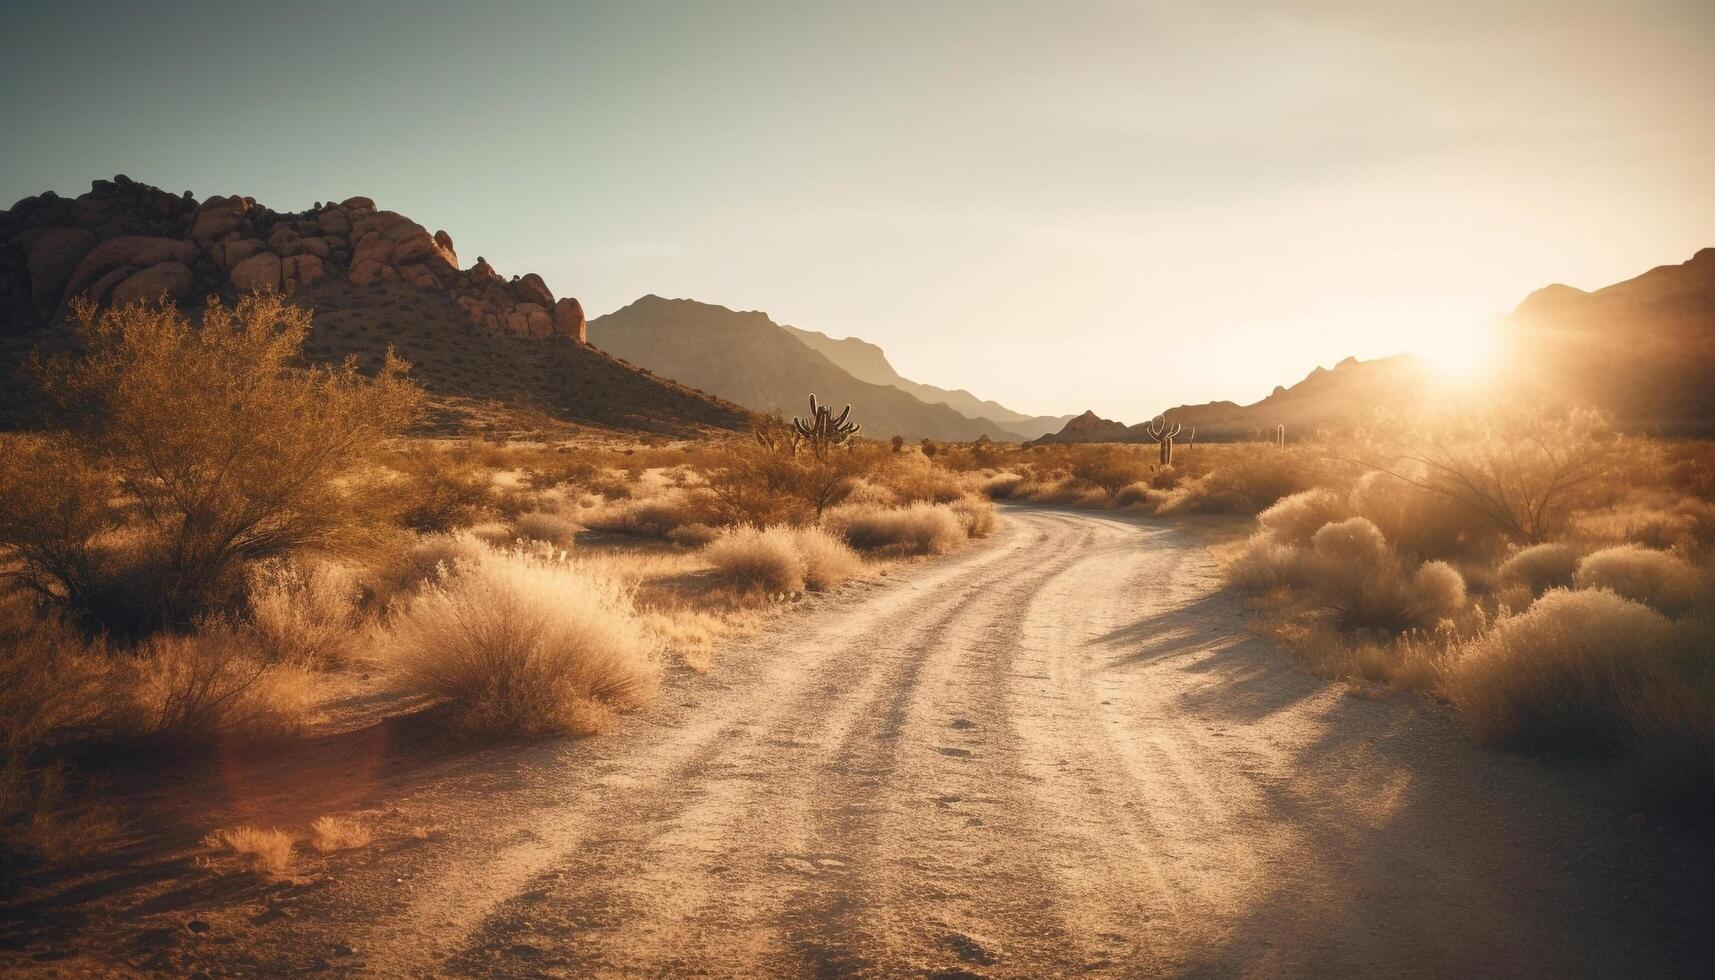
[1302,517,1465,633]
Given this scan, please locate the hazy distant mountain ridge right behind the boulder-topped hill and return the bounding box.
[590,295,1020,441]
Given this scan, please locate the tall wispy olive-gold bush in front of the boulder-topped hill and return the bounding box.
[0,295,422,635]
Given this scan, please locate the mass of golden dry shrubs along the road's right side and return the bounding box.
[1199,408,1715,805]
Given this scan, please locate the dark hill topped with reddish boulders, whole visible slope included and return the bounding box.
[0,177,748,434]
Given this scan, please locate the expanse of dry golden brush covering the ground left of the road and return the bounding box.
[0,297,995,879]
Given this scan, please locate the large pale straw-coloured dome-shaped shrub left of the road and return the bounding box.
[391,551,659,735]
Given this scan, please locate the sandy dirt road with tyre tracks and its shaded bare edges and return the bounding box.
[0,508,1715,977]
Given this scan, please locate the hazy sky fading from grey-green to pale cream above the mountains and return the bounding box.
[0,0,1715,422]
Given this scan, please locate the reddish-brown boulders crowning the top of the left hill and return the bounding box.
[0,177,587,343]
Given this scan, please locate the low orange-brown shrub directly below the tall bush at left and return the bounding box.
[120,621,314,741]
